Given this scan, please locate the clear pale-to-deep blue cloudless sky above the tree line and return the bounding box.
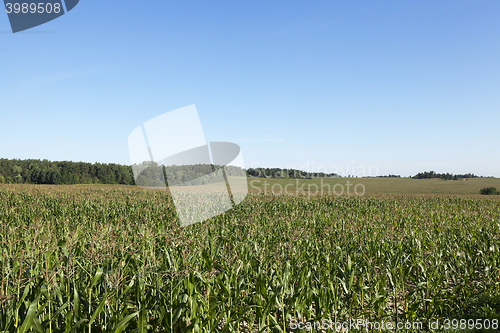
[0,0,500,177]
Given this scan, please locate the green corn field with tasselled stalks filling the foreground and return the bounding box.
[0,185,500,333]
